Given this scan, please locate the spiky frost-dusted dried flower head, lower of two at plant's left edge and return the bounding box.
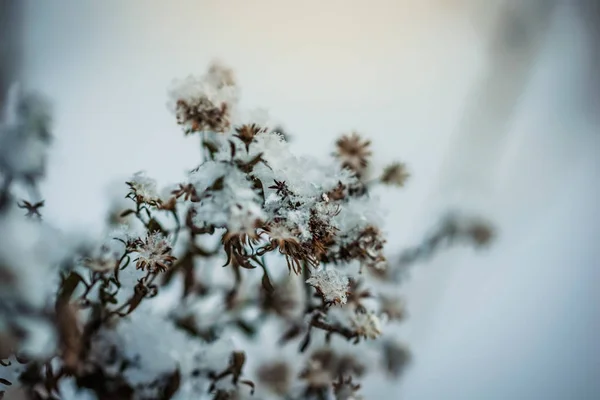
[134,232,176,273]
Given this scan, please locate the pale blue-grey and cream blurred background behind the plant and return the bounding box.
[0,0,600,400]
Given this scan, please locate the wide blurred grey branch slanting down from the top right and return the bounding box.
[441,0,557,191]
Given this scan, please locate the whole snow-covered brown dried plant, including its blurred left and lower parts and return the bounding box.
[0,64,492,400]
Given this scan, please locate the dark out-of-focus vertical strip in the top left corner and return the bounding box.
[0,0,22,109]
